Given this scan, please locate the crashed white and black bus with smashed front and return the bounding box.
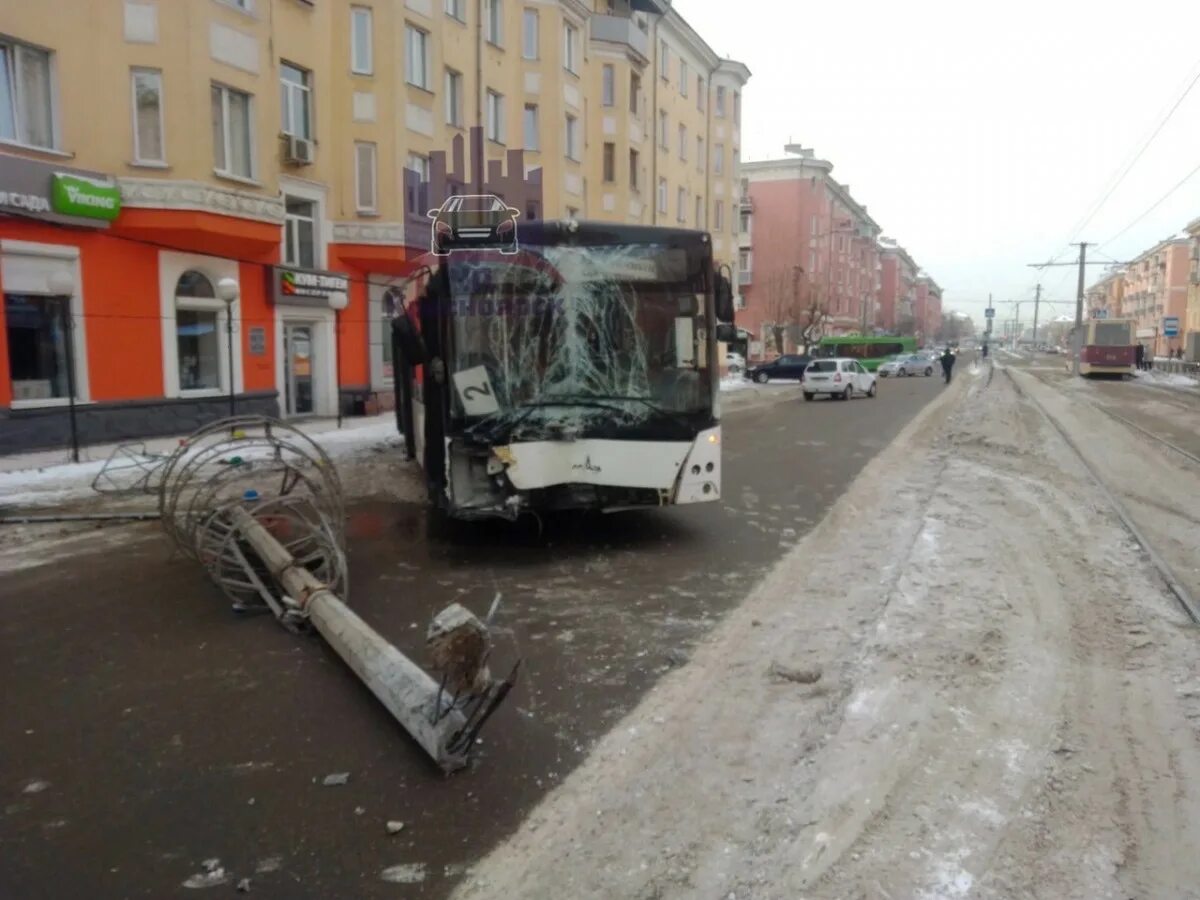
[385,221,733,520]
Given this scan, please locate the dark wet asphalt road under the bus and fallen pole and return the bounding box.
[0,378,942,900]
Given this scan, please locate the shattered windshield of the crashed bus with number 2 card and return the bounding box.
[448,245,712,434]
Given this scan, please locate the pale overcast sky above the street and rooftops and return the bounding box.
[674,0,1200,323]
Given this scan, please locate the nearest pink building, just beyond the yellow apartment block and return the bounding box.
[738,145,880,359]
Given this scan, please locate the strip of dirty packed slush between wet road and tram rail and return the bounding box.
[456,372,1200,900]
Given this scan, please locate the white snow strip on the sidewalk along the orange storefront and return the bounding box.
[0,413,400,506]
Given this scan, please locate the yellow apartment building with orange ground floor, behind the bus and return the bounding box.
[0,0,750,452]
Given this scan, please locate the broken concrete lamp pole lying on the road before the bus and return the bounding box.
[227,506,472,773]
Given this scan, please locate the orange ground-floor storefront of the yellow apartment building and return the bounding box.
[0,155,407,452]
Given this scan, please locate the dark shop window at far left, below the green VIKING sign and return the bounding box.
[4,294,71,400]
